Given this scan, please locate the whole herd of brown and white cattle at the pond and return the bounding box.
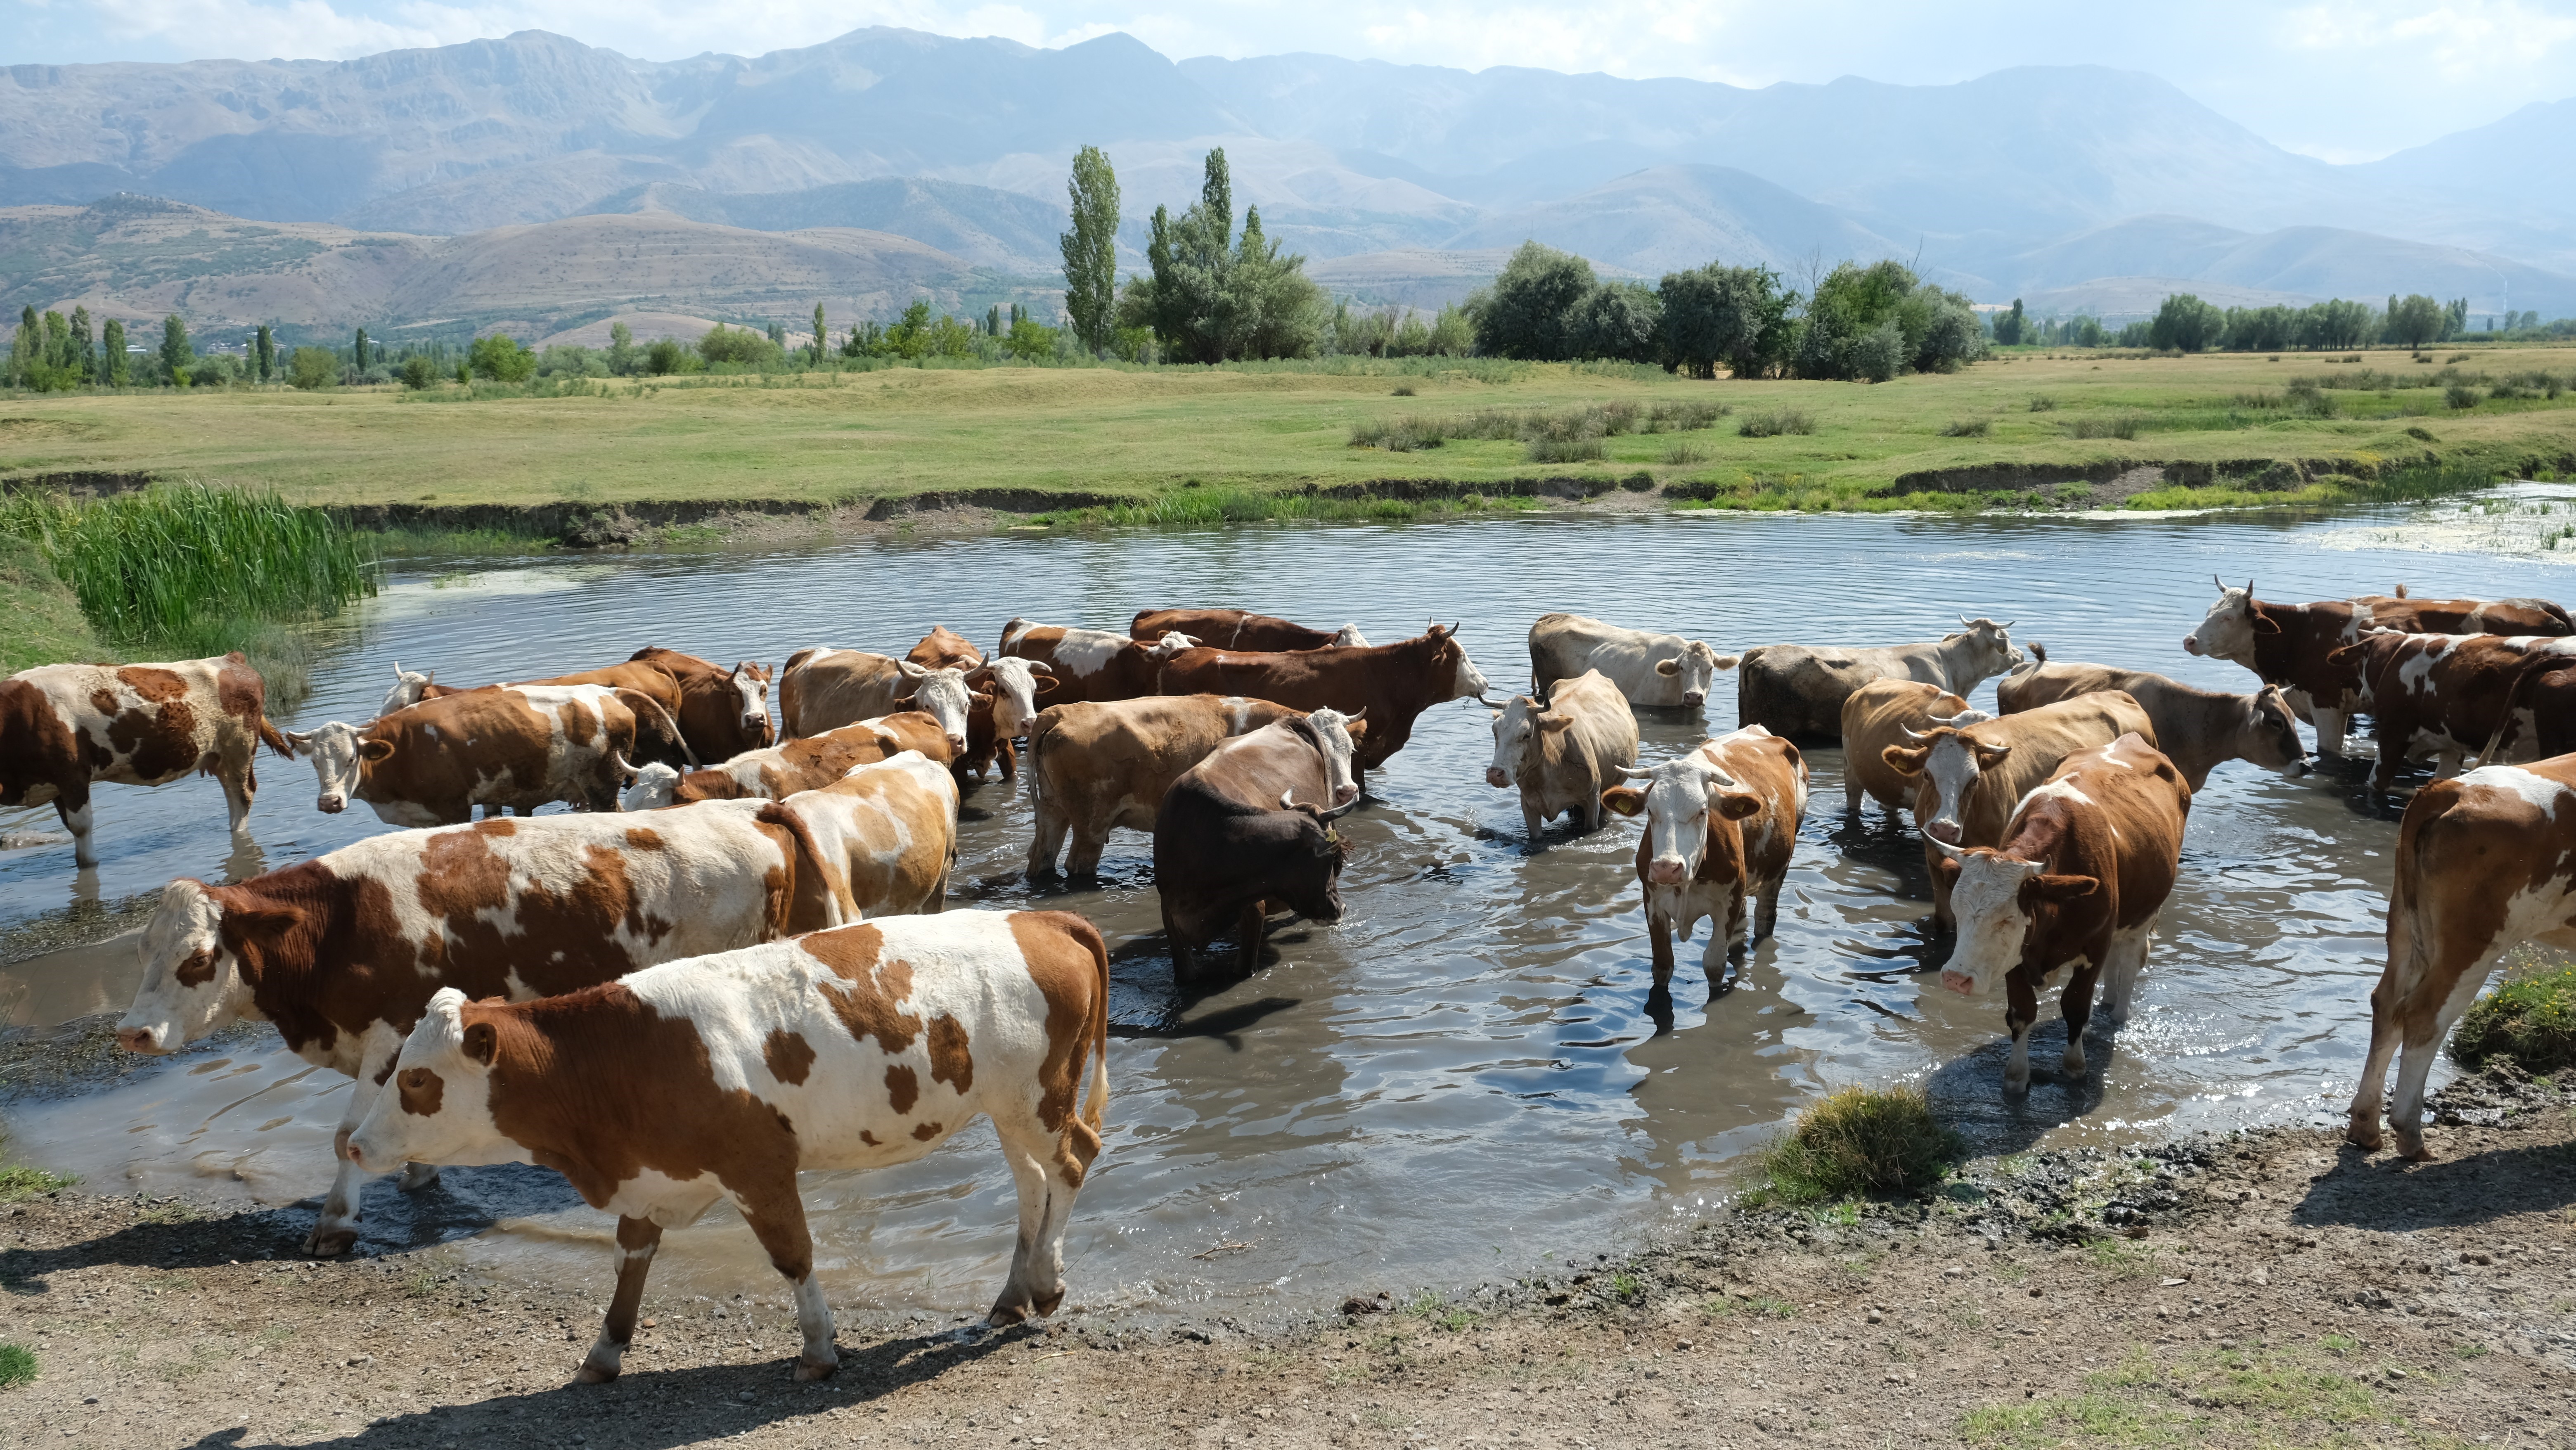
[0,585,2576,1381]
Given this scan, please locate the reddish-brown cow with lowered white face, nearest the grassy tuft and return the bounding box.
[1934,734,2192,1092]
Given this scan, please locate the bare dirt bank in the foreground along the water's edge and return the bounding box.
[0,1079,2576,1450]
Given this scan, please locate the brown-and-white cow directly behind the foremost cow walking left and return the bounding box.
[116,798,845,1254]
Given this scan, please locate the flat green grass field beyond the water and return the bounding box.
[0,348,2576,520]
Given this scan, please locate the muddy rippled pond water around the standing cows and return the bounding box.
[0,505,2568,1313]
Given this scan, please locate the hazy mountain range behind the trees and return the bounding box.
[0,28,2576,320]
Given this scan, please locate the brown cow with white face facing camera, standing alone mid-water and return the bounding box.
[1602,726,1806,997]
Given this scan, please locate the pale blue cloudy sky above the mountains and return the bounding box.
[0,0,2576,162]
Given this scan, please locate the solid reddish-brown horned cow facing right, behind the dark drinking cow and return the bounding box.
[1162,623,1492,770]
